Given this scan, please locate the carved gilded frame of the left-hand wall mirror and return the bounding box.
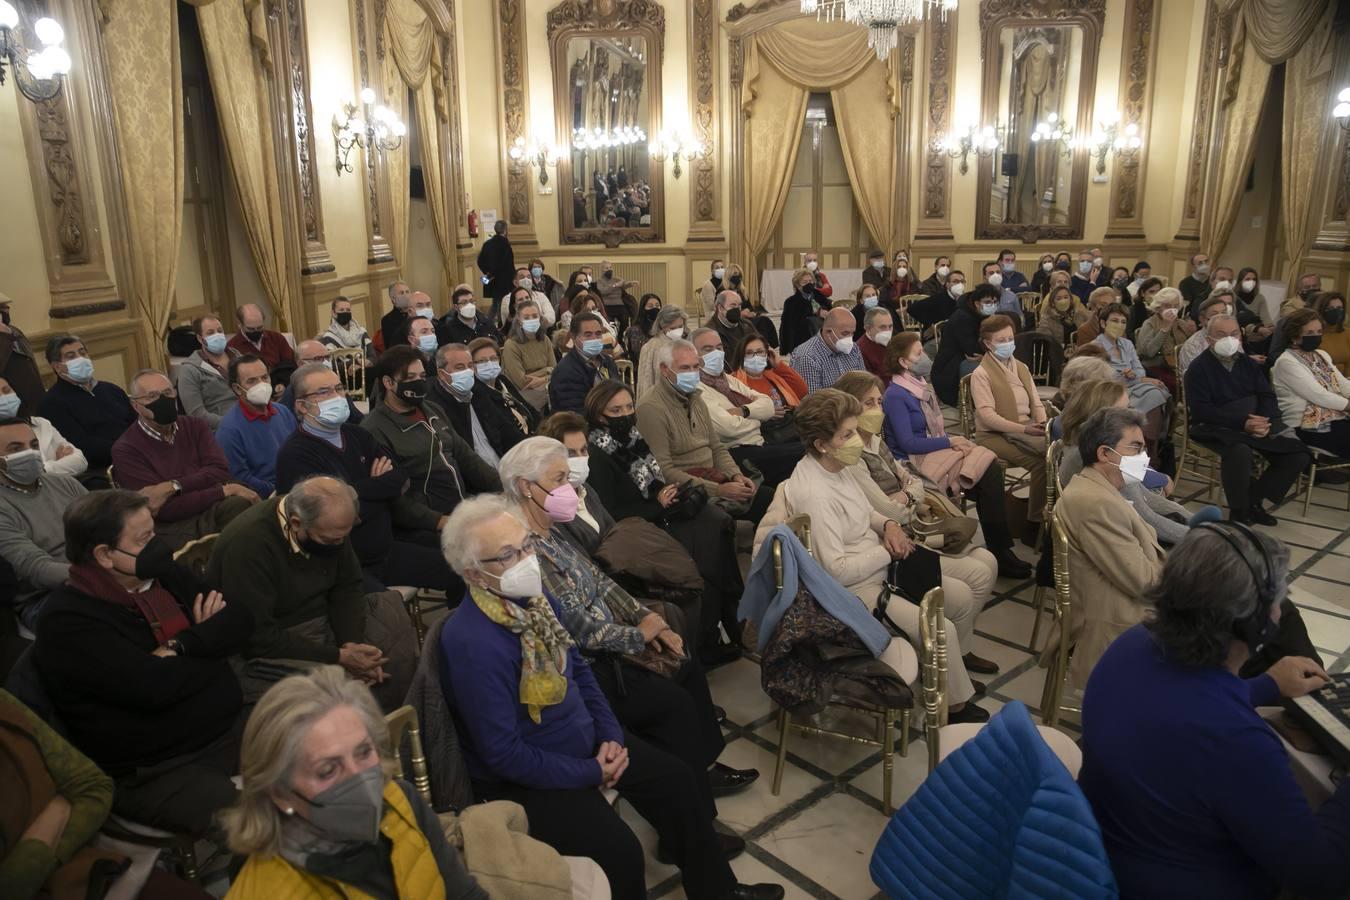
[548,0,666,248]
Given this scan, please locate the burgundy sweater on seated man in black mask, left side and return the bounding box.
[112,416,230,522]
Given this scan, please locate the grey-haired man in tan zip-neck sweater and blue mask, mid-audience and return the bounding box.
[636,340,772,522]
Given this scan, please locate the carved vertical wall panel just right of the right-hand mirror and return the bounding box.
[1106,0,1161,239]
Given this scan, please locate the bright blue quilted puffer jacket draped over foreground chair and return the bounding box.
[869,702,1119,900]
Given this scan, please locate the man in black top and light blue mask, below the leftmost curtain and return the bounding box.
[38,335,136,472]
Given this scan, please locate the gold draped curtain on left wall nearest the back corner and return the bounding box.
[385,0,459,285]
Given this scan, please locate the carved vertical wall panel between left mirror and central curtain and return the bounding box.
[689,0,724,242]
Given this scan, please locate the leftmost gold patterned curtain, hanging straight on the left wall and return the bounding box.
[100,0,184,359]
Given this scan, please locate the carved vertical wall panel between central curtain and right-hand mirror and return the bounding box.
[914,4,959,240]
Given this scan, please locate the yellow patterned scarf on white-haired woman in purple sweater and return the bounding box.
[468,586,572,725]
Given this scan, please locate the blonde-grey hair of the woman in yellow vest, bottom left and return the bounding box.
[220,665,397,857]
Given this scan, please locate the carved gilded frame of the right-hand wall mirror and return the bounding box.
[975,0,1106,244]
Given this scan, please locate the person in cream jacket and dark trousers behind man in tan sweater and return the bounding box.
[693,329,802,486]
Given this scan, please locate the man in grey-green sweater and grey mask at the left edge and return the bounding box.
[0,418,86,630]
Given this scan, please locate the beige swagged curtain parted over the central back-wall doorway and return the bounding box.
[741,19,898,294]
